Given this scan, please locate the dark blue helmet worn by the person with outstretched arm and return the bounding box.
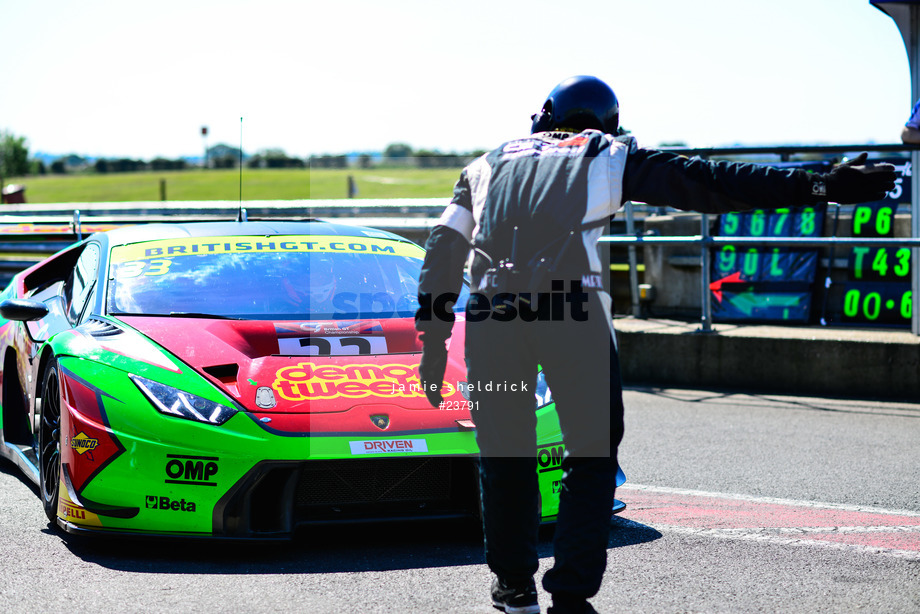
[530,76,620,134]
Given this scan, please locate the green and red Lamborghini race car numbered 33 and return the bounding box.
[0,221,624,539]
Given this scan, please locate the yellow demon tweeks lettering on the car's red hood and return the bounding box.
[272,362,425,401]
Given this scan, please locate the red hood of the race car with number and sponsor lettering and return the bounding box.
[119,316,468,430]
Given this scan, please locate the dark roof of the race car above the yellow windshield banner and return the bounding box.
[93,220,411,245]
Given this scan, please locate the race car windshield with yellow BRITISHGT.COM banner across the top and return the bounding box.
[107,235,465,320]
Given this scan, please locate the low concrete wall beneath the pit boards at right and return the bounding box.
[615,318,920,402]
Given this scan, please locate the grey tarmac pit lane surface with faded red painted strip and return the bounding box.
[0,388,920,614]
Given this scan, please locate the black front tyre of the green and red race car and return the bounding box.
[38,359,61,523]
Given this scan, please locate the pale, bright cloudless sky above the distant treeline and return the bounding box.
[0,0,912,159]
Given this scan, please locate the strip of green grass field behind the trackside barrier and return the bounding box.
[6,169,460,203]
